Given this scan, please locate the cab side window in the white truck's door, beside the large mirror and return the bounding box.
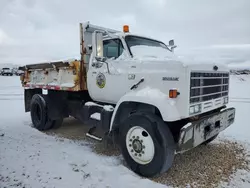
[103,39,123,58]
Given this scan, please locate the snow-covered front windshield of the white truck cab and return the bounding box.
[125,35,173,58]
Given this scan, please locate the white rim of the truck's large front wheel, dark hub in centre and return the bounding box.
[126,126,155,165]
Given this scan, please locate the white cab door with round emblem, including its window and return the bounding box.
[88,38,130,104]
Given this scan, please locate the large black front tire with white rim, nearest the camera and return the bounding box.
[119,113,175,177]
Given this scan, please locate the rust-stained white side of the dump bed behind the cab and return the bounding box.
[19,60,87,91]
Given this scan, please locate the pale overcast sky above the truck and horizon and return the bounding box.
[0,0,250,64]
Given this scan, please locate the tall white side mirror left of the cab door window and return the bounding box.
[92,31,103,57]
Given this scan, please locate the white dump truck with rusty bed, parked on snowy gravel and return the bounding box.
[20,22,235,177]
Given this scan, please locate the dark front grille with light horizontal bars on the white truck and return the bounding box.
[190,72,229,103]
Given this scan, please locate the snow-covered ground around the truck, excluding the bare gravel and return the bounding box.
[0,76,250,188]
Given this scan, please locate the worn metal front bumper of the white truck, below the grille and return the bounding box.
[176,108,235,153]
